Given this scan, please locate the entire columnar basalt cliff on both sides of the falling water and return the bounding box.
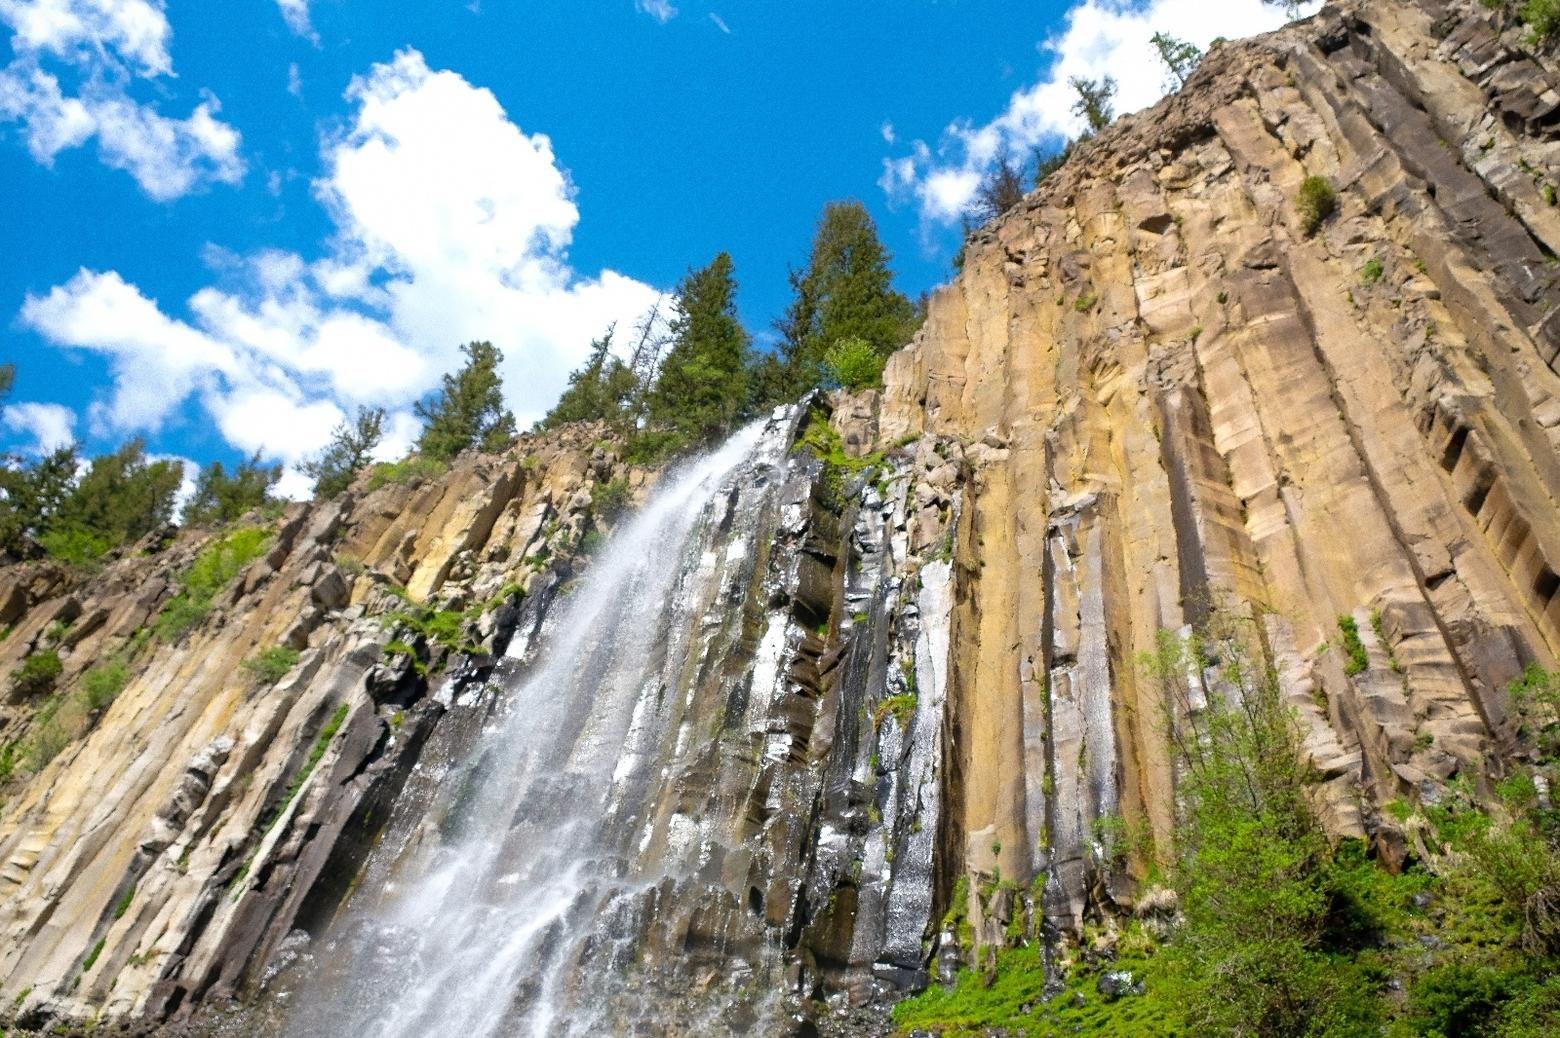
[0,0,1560,1033]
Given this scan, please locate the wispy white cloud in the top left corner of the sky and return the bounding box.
[0,0,245,201]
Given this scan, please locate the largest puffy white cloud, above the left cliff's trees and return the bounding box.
[22,50,660,492]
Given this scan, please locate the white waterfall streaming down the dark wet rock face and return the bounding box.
[280,417,792,1038]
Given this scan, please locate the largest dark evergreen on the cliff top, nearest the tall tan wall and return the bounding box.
[775,201,916,395]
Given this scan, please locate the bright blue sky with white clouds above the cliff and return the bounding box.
[0,0,1304,492]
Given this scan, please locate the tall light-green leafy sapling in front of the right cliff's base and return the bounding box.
[1143,617,1377,1035]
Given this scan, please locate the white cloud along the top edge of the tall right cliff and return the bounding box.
[878,0,1321,223]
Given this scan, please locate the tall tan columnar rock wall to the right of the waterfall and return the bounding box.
[881,0,1560,924]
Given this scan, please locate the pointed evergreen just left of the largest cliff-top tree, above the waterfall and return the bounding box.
[649,253,749,443]
